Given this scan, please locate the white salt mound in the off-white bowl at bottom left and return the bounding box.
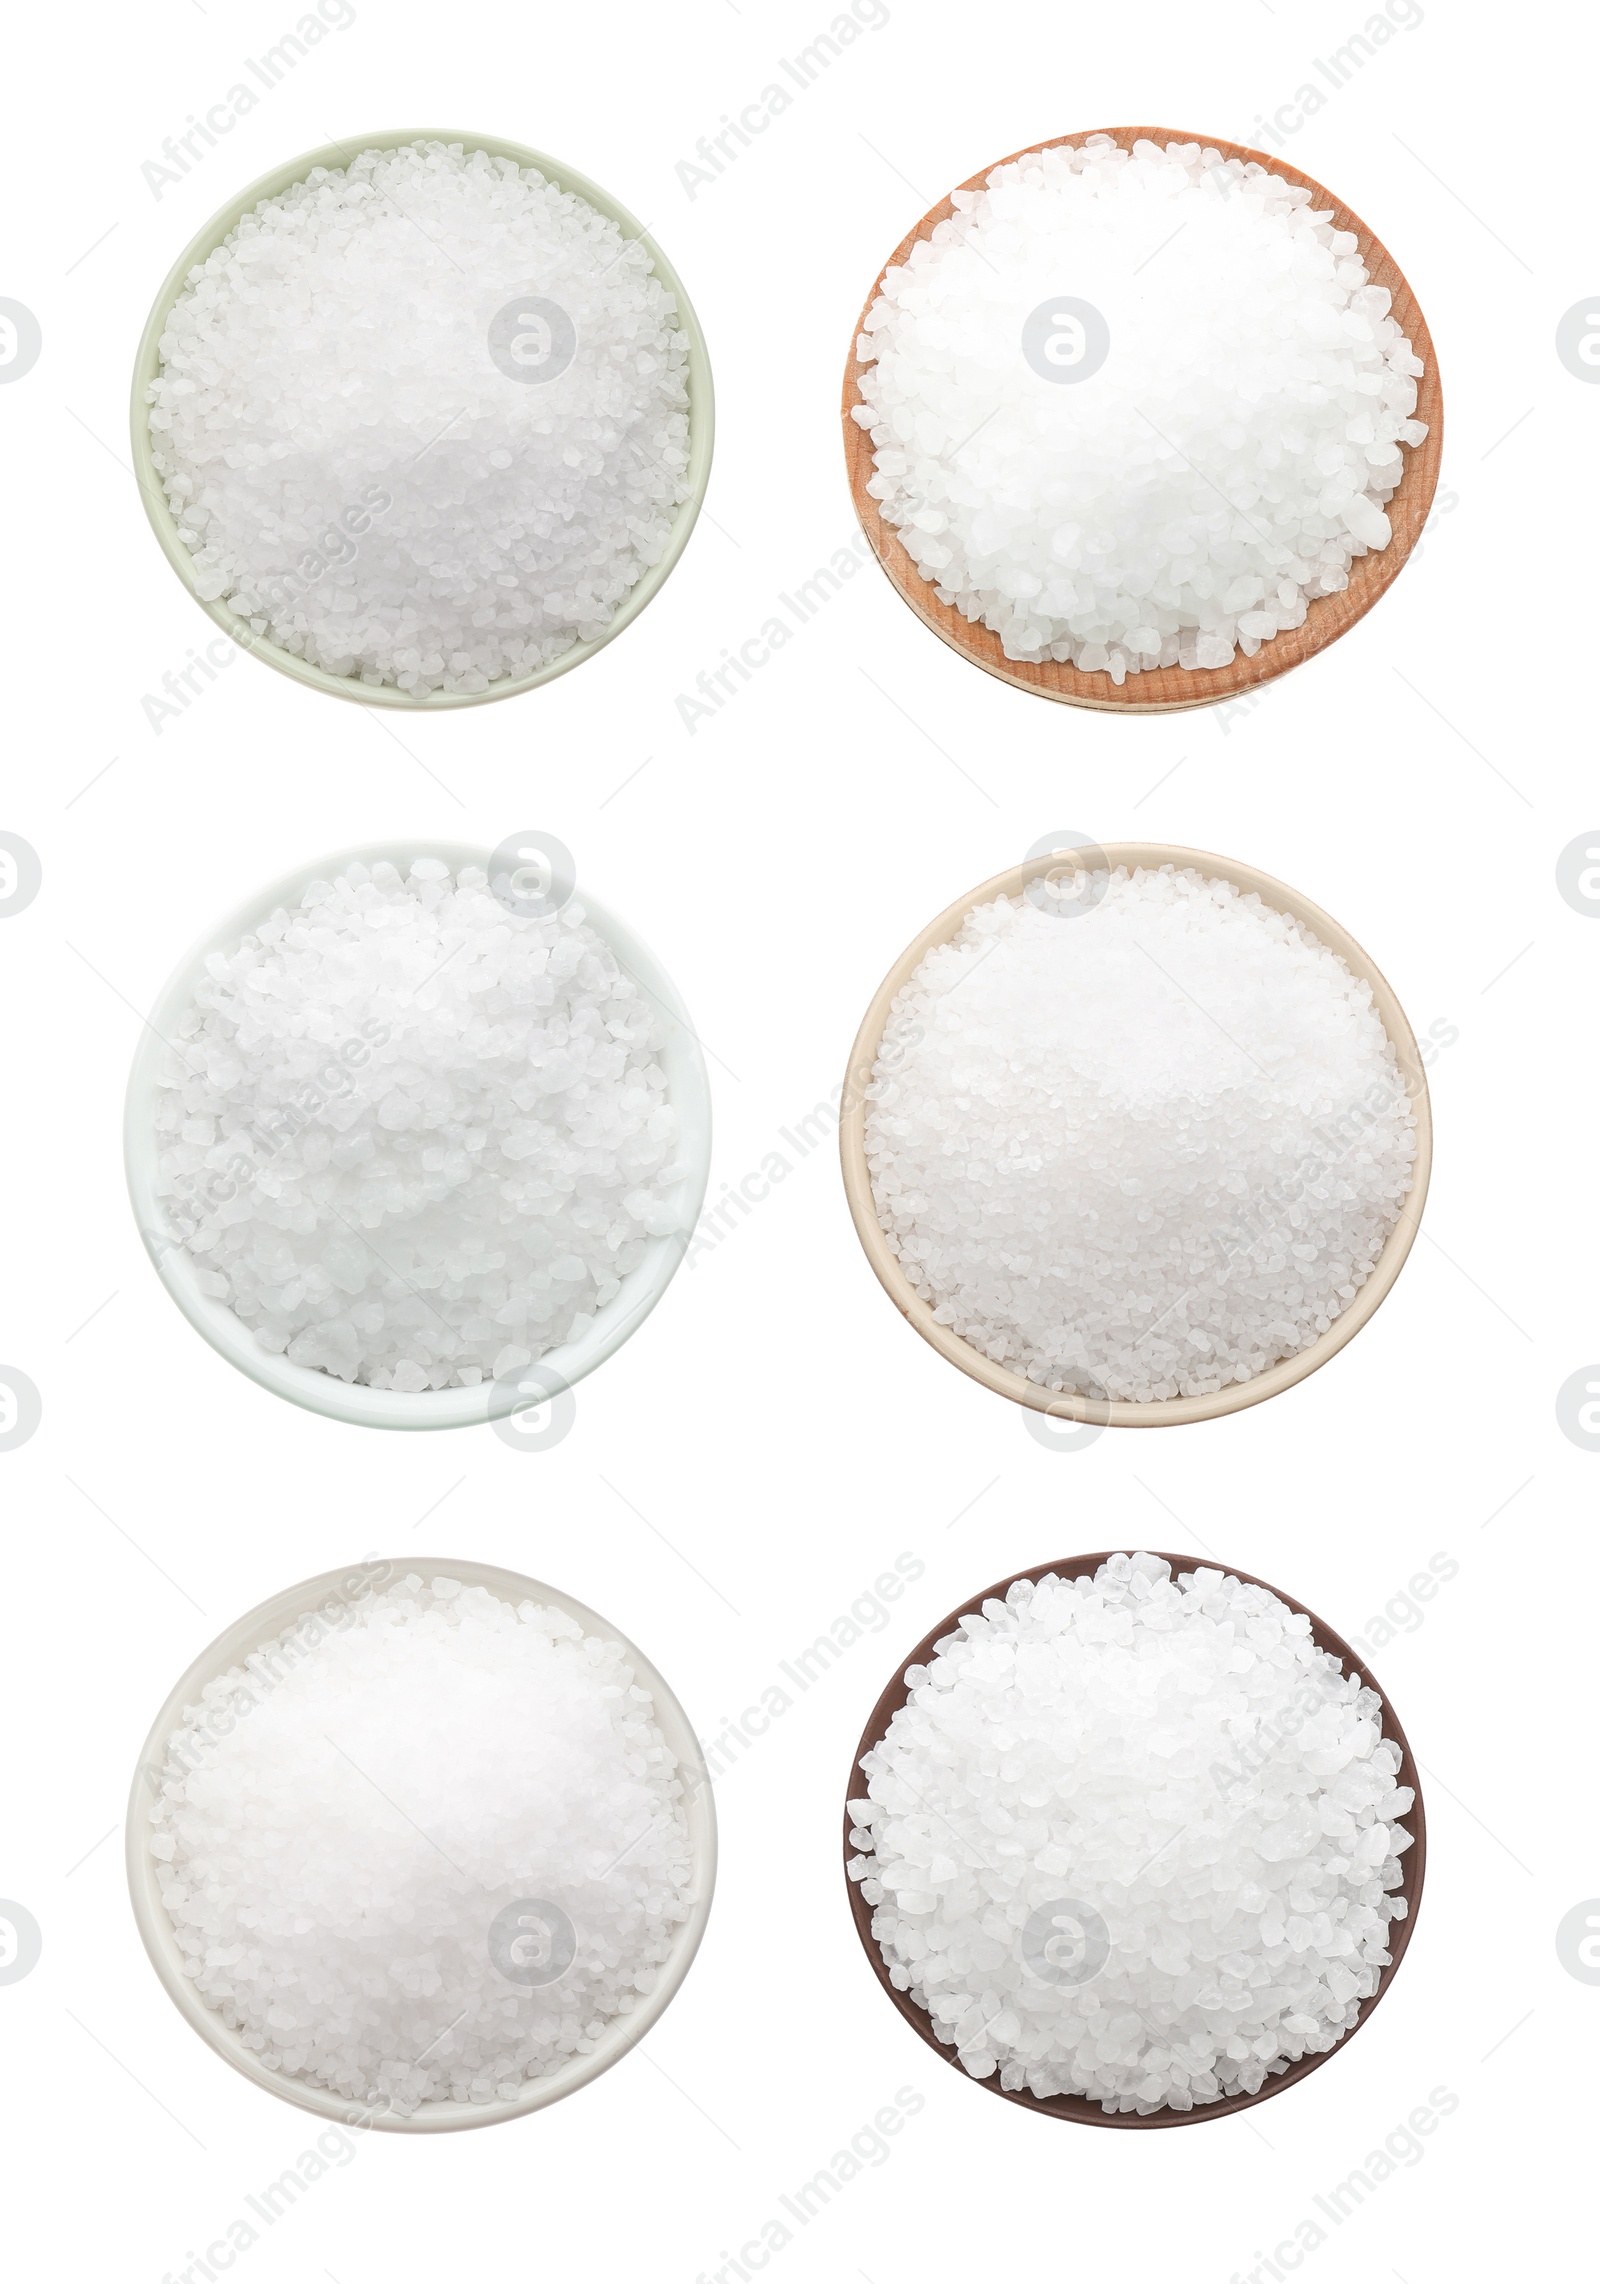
[148,1574,694,2117]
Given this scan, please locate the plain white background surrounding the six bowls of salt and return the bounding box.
[0,0,1600,2284]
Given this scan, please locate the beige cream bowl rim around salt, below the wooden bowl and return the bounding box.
[840,841,1433,1428]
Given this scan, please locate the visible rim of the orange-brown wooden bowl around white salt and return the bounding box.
[840,128,1445,713]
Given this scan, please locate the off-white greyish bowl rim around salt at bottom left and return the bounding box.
[123,1555,717,2133]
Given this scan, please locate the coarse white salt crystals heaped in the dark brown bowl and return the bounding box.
[849,1553,1415,2117]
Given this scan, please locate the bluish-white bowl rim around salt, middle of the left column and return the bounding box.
[123,834,712,1430]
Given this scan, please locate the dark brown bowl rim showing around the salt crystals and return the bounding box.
[845,1546,1429,2126]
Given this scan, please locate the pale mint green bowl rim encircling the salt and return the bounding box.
[132,128,714,713]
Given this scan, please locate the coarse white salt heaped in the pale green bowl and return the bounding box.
[148,142,689,694]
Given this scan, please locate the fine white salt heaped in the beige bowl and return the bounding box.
[865,866,1415,1402]
